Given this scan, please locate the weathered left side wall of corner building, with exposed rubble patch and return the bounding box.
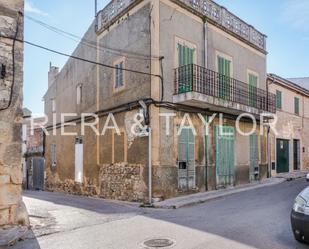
[44,1,151,201]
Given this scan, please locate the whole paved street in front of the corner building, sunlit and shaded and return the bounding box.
[13,179,308,249]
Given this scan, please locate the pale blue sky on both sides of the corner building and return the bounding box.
[24,0,309,115]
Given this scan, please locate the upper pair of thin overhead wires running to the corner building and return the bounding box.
[25,15,160,60]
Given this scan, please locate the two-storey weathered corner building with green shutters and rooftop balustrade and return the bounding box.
[44,0,275,201]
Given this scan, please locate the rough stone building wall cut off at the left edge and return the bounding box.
[0,0,29,226]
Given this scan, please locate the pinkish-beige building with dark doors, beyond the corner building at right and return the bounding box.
[267,74,309,175]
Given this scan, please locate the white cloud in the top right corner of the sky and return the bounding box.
[281,0,309,30]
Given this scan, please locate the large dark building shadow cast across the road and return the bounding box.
[21,180,308,249]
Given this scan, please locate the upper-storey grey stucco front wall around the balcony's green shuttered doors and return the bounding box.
[160,1,266,101]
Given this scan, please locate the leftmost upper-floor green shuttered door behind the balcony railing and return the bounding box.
[177,43,195,93]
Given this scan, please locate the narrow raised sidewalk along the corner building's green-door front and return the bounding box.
[153,172,307,209]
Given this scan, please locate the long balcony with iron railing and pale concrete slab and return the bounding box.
[173,64,276,115]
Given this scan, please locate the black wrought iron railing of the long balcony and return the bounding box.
[175,64,276,113]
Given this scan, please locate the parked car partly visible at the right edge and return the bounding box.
[291,187,309,242]
